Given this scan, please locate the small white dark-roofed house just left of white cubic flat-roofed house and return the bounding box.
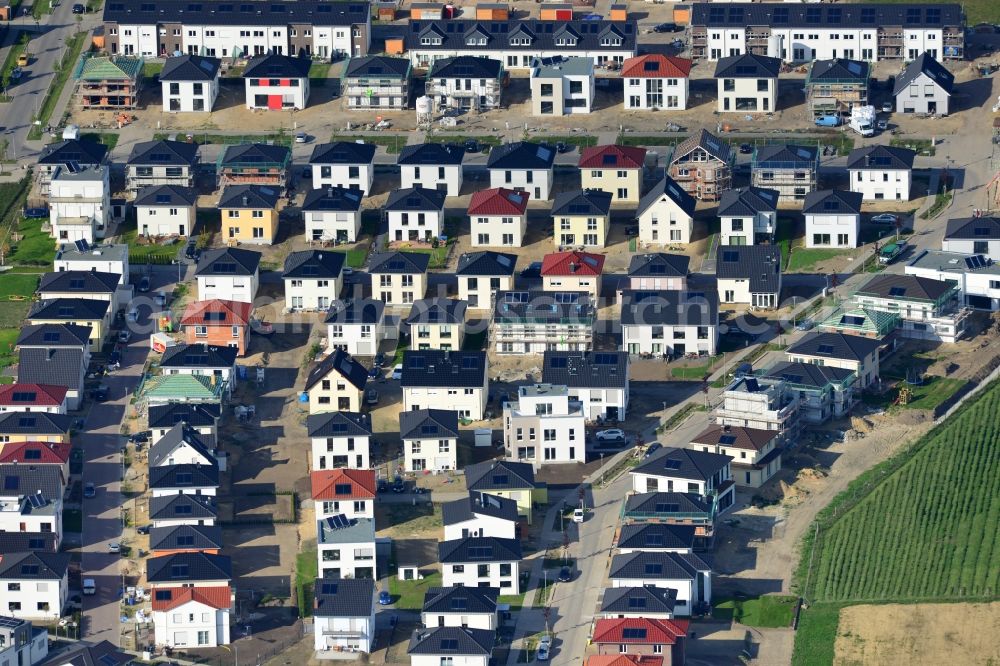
[399,409,458,473]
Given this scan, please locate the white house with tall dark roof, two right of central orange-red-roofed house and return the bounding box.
[715,245,781,310]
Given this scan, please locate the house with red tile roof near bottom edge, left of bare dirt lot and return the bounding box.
[588,617,690,666]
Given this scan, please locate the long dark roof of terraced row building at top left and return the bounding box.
[104,0,371,26]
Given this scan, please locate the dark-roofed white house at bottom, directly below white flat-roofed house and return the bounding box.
[312,578,375,655]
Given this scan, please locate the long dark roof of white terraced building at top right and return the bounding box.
[691,2,965,29]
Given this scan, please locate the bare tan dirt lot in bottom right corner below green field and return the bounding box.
[834,603,1000,666]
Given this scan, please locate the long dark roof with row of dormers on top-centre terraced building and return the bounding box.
[405,18,638,56]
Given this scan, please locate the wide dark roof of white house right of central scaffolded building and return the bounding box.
[621,289,719,326]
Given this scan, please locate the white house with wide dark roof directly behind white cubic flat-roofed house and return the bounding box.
[542,351,629,421]
